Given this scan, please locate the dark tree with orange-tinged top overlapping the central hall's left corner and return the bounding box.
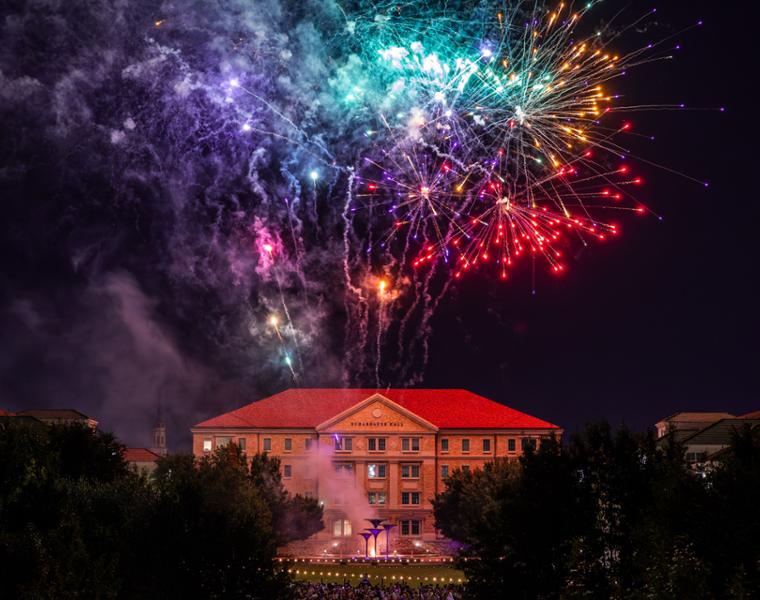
[144,444,288,598]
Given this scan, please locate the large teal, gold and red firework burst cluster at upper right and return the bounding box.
[355,3,684,279]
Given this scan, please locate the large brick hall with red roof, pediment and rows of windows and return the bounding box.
[192,389,562,554]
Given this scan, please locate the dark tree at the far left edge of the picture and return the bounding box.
[0,418,147,598]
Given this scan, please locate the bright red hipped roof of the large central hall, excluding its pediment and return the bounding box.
[191,388,559,429]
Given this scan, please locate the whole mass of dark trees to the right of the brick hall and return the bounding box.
[434,424,760,600]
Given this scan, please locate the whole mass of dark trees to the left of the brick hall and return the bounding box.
[0,418,322,600]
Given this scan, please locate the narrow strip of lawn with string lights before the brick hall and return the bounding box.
[287,562,465,586]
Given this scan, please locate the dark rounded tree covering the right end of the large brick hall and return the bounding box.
[433,438,588,598]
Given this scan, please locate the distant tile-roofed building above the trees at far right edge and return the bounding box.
[656,411,760,470]
